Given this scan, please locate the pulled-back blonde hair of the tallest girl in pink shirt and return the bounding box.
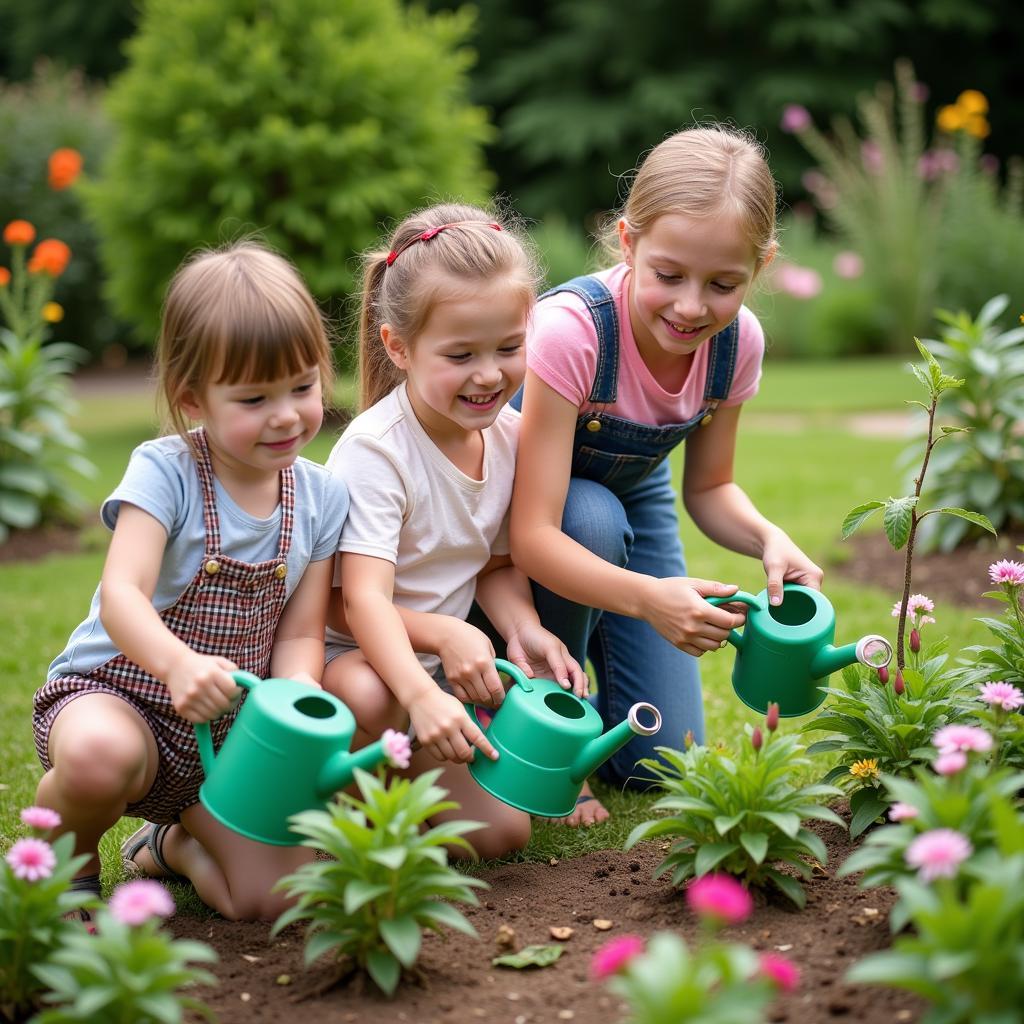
[604,124,778,267]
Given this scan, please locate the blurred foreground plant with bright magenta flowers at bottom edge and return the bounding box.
[591,874,800,1024]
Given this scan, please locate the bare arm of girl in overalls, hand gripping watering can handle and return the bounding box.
[511,370,743,657]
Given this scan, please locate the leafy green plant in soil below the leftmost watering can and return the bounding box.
[272,769,487,995]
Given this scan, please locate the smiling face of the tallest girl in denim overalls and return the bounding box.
[618,213,758,371]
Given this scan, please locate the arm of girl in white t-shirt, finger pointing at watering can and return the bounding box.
[341,553,498,762]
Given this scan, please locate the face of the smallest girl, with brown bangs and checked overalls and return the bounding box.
[182,367,324,477]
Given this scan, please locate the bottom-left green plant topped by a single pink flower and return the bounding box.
[34,880,217,1024]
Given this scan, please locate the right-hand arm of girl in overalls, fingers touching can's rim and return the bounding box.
[683,406,823,604]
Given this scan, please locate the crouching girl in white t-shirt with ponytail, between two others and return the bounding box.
[324,204,587,857]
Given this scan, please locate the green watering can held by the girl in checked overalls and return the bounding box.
[196,672,387,846]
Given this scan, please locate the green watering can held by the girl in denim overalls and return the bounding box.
[707,584,893,718]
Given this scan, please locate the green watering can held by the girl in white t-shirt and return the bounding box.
[465,658,662,818]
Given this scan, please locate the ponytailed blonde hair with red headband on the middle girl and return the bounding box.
[358,203,540,409]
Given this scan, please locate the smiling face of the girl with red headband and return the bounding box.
[381,280,530,437]
